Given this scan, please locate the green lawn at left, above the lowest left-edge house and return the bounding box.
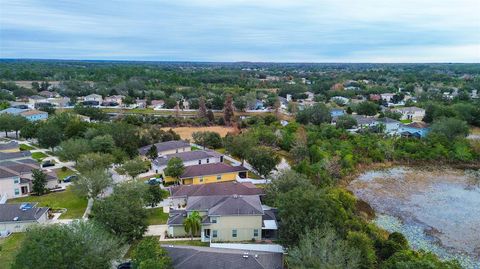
[8,187,87,219]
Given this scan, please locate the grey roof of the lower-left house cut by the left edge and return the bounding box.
[0,203,48,222]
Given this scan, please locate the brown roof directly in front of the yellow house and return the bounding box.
[170,181,263,197]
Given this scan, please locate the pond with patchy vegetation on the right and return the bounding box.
[348,167,480,269]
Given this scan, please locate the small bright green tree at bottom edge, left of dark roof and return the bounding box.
[132,237,173,269]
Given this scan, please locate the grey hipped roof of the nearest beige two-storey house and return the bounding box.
[186,195,263,216]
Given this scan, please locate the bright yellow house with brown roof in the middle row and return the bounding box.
[165,162,248,184]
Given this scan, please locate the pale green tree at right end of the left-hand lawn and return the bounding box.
[72,169,113,199]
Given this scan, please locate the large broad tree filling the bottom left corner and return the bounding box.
[12,221,122,269]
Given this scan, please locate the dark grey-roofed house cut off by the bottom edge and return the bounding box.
[162,245,283,269]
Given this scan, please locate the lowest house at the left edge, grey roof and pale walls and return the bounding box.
[0,203,49,233]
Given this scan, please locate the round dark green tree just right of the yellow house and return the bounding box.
[247,147,280,177]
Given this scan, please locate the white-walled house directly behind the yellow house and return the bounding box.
[152,150,223,174]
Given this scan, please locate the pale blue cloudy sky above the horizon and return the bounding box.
[0,0,480,63]
